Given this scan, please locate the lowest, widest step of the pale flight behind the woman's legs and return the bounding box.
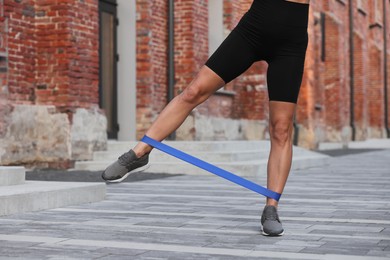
[75,153,329,177]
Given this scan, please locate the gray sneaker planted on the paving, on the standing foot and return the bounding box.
[261,205,284,236]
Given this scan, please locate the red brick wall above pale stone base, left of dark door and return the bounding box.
[4,0,99,111]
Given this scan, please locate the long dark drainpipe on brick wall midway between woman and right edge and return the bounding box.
[349,0,356,141]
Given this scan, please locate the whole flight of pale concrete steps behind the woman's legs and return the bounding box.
[75,141,329,177]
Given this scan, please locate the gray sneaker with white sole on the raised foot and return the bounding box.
[102,150,149,182]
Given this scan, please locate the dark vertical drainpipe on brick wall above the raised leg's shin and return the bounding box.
[167,0,176,140]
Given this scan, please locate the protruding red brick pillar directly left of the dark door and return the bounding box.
[35,0,99,111]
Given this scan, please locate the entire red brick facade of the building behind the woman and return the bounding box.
[0,0,390,152]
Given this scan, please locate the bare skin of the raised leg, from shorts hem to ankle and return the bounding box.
[133,66,225,157]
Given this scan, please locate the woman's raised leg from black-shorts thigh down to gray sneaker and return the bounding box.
[102,27,256,182]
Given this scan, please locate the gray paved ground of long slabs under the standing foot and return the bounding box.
[0,150,390,260]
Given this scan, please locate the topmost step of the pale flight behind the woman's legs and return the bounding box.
[107,140,270,153]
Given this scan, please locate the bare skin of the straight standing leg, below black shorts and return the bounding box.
[267,101,296,207]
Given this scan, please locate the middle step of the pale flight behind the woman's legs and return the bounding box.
[93,149,269,162]
